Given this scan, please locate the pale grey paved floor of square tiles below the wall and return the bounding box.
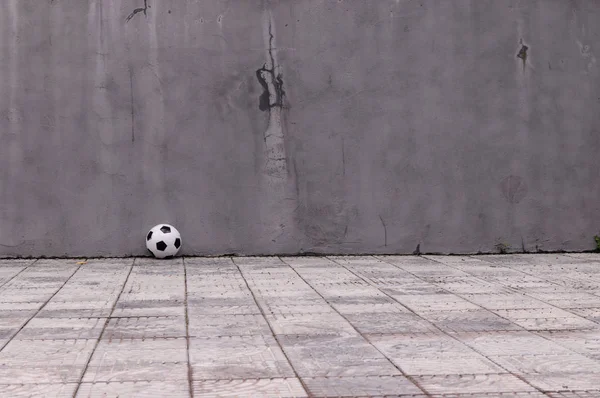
[0,254,600,398]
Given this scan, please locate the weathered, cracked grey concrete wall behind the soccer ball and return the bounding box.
[0,0,600,256]
